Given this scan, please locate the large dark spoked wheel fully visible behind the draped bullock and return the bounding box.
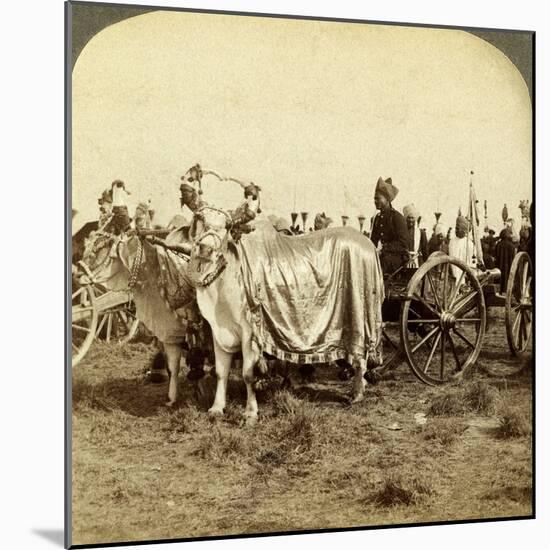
[400,256,486,385]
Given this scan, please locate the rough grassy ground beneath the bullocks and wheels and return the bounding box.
[72,313,533,544]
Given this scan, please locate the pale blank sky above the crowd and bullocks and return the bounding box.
[72,11,532,234]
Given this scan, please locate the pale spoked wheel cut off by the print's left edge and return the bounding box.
[71,285,99,367]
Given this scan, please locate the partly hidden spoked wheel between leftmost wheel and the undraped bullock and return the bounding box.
[96,288,139,344]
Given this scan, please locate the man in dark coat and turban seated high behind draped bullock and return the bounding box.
[370,178,409,273]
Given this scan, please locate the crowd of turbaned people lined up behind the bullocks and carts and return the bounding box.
[84,178,533,298]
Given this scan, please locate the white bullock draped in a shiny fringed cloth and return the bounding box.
[188,204,384,424]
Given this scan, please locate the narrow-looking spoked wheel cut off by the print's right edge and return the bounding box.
[505,252,533,357]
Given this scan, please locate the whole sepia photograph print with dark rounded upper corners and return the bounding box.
[65,1,536,547]
